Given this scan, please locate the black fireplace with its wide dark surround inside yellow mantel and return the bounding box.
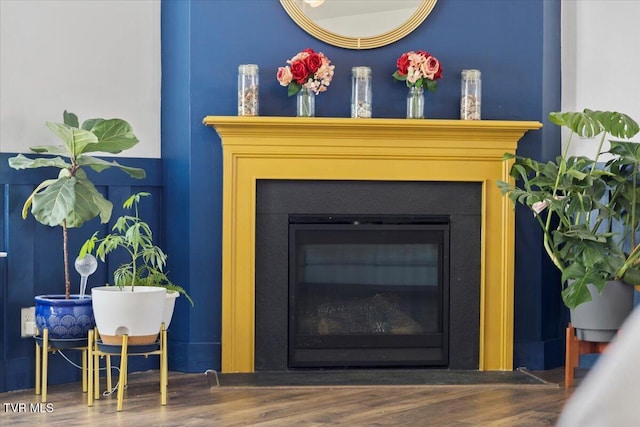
[254,179,482,371]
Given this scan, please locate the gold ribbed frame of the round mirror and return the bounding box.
[280,0,438,49]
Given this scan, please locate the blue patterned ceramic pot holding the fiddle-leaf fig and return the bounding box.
[35,295,96,339]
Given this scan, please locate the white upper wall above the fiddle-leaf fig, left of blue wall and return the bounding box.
[0,0,160,158]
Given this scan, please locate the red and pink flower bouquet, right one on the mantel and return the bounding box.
[393,50,442,92]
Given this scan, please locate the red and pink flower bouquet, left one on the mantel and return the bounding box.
[276,49,335,96]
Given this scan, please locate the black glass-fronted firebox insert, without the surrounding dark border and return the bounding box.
[288,215,450,368]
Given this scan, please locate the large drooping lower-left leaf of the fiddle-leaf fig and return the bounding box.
[31,177,76,227]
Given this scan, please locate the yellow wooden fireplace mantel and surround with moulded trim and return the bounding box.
[204,116,542,372]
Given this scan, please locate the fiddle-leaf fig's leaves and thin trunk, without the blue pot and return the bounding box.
[9,111,145,299]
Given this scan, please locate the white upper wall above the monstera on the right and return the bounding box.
[562,0,640,156]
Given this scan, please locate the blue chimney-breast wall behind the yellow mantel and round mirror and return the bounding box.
[162,0,564,371]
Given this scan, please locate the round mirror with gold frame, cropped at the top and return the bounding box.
[280,0,437,49]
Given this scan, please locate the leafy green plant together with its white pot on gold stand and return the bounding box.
[78,192,193,345]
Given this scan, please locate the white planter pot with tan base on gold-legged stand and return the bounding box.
[91,286,167,345]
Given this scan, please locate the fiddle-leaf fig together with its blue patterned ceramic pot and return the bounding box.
[9,111,145,339]
